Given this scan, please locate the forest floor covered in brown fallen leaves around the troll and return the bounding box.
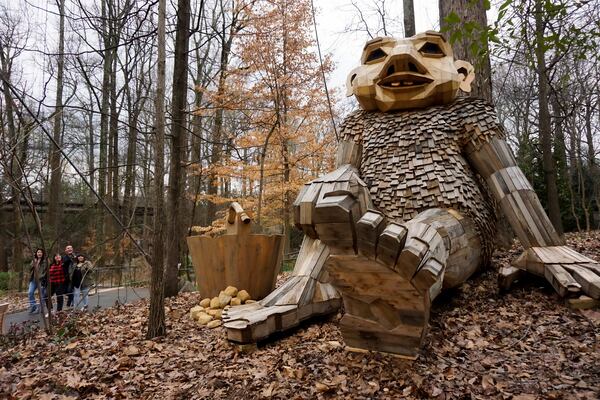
[0,232,600,400]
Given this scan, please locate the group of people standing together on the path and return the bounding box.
[29,245,93,314]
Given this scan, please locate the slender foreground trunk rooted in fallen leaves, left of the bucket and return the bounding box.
[146,0,167,339]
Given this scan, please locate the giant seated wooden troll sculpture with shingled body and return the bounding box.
[223,32,600,358]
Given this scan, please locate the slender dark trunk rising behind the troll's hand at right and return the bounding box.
[535,0,563,234]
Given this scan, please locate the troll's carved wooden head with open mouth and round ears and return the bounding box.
[346,31,475,112]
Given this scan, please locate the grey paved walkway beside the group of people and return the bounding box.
[2,287,150,333]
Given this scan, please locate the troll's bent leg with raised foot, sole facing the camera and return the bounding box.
[326,209,481,358]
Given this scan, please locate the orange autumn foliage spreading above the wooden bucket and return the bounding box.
[197,0,336,233]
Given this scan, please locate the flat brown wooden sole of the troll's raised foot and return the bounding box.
[326,255,431,357]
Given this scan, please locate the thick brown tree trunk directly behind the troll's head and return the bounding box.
[439,0,493,103]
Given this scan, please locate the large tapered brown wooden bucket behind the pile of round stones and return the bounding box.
[187,234,283,300]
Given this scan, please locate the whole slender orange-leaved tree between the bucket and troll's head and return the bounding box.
[227,0,333,249]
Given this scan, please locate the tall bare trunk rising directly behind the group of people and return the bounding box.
[48,0,65,249]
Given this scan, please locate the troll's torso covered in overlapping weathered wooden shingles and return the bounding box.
[342,98,503,256]
